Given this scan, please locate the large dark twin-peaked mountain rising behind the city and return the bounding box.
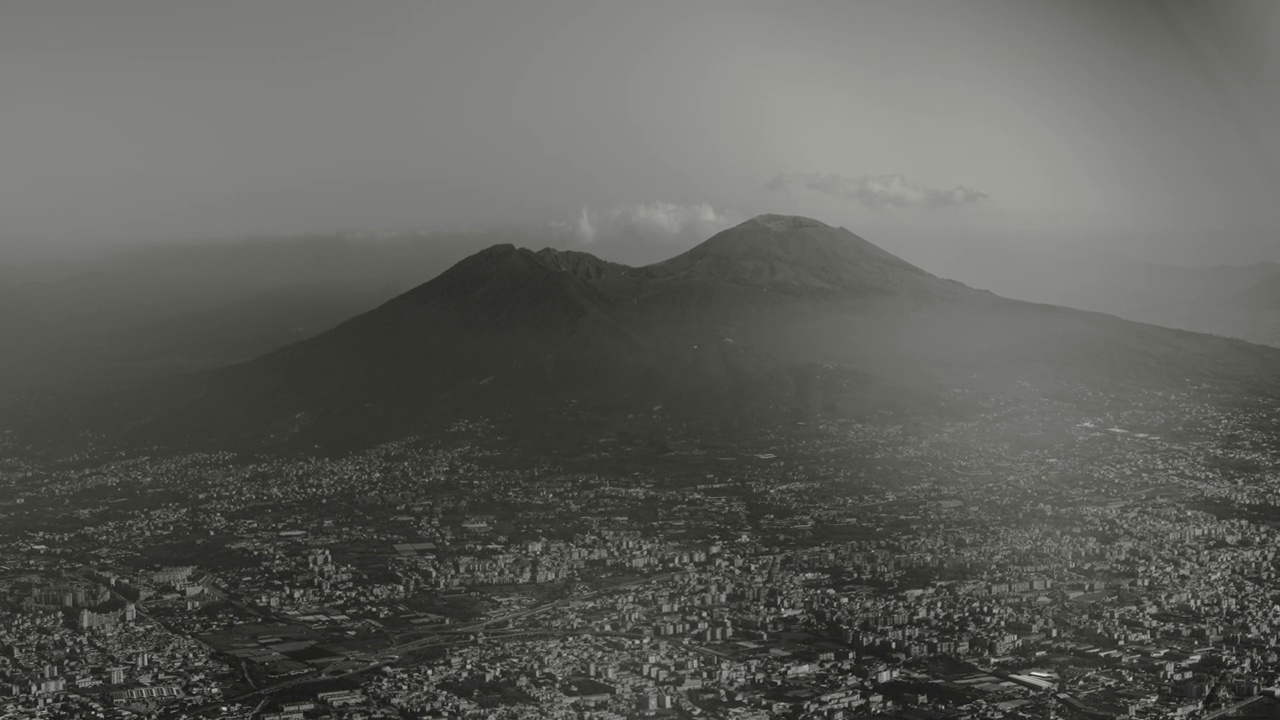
[17,215,1280,443]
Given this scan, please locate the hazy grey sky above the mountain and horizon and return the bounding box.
[0,0,1280,263]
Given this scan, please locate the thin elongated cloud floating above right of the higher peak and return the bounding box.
[764,173,988,210]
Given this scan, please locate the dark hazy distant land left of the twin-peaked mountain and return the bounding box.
[0,234,493,400]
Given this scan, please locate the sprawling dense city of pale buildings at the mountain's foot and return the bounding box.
[0,391,1280,720]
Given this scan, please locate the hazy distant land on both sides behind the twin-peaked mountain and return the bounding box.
[0,228,1280,404]
